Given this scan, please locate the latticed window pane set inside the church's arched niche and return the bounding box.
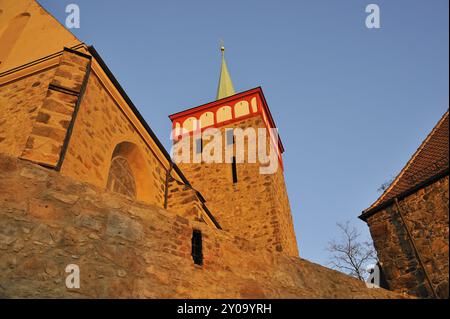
[106,156,136,198]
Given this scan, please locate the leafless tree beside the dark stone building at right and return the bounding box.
[327,221,377,281]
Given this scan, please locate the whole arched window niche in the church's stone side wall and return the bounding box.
[106,142,154,202]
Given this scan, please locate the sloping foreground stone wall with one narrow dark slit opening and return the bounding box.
[0,155,401,298]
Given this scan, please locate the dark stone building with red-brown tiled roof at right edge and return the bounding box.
[360,111,449,298]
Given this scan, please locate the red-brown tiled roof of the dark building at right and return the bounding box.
[360,110,449,220]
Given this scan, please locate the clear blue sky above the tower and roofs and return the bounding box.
[40,0,449,264]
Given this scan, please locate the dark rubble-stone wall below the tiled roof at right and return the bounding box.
[367,176,449,298]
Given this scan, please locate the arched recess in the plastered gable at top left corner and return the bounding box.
[0,12,31,65]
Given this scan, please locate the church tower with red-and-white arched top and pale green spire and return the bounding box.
[169,46,298,256]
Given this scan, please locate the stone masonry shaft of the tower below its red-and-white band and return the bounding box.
[179,115,298,256]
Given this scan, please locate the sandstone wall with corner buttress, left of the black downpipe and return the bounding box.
[0,51,90,167]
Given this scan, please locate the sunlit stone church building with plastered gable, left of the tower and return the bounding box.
[0,0,218,231]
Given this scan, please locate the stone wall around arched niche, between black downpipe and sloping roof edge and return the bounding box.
[61,73,166,207]
